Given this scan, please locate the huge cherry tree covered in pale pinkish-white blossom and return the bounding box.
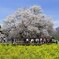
[3,6,54,38]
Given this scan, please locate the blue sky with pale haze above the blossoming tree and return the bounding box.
[0,0,59,28]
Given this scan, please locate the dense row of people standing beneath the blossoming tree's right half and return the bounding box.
[24,37,54,44]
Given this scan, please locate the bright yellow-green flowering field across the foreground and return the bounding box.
[0,44,59,59]
